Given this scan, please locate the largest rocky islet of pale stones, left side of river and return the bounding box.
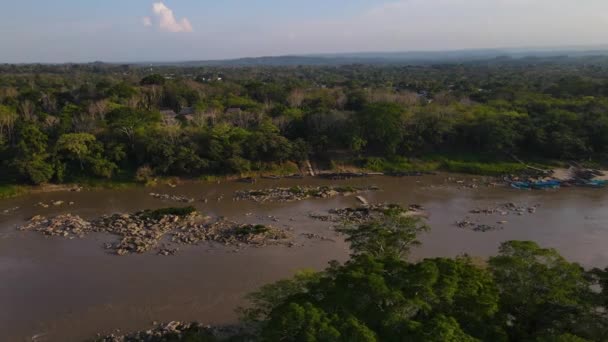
[19,210,290,255]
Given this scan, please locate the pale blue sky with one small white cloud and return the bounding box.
[0,0,608,63]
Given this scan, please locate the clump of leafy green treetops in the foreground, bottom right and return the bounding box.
[244,220,608,342]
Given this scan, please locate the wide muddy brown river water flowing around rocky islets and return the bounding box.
[0,175,608,341]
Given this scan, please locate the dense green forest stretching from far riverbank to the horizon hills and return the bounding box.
[0,57,608,188]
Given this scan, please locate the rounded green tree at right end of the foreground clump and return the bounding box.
[489,241,605,341]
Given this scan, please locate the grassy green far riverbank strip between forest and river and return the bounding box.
[0,155,608,203]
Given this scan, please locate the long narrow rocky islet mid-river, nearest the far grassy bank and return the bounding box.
[234,186,379,202]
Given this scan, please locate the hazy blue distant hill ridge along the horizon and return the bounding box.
[136,47,608,67]
